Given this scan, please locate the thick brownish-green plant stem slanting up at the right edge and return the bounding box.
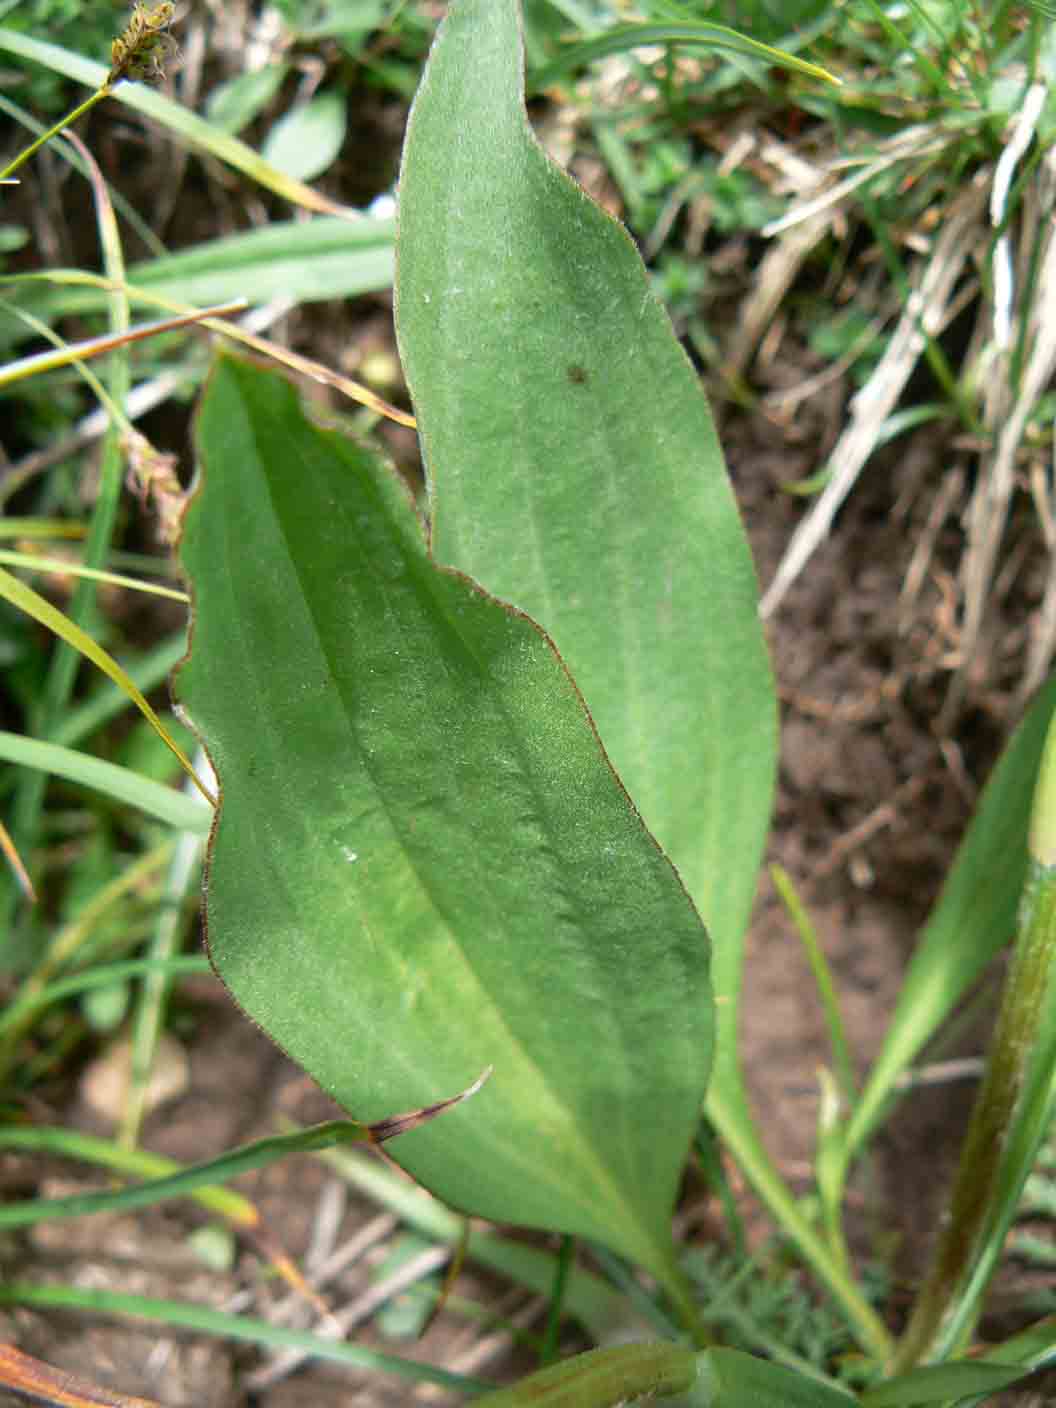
[894,860,1056,1371]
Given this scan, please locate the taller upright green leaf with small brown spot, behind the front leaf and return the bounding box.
[396,0,776,1120]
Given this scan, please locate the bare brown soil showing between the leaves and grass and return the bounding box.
[0,66,1056,1408]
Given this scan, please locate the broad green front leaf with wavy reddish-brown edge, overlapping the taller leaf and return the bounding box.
[179,358,711,1288]
